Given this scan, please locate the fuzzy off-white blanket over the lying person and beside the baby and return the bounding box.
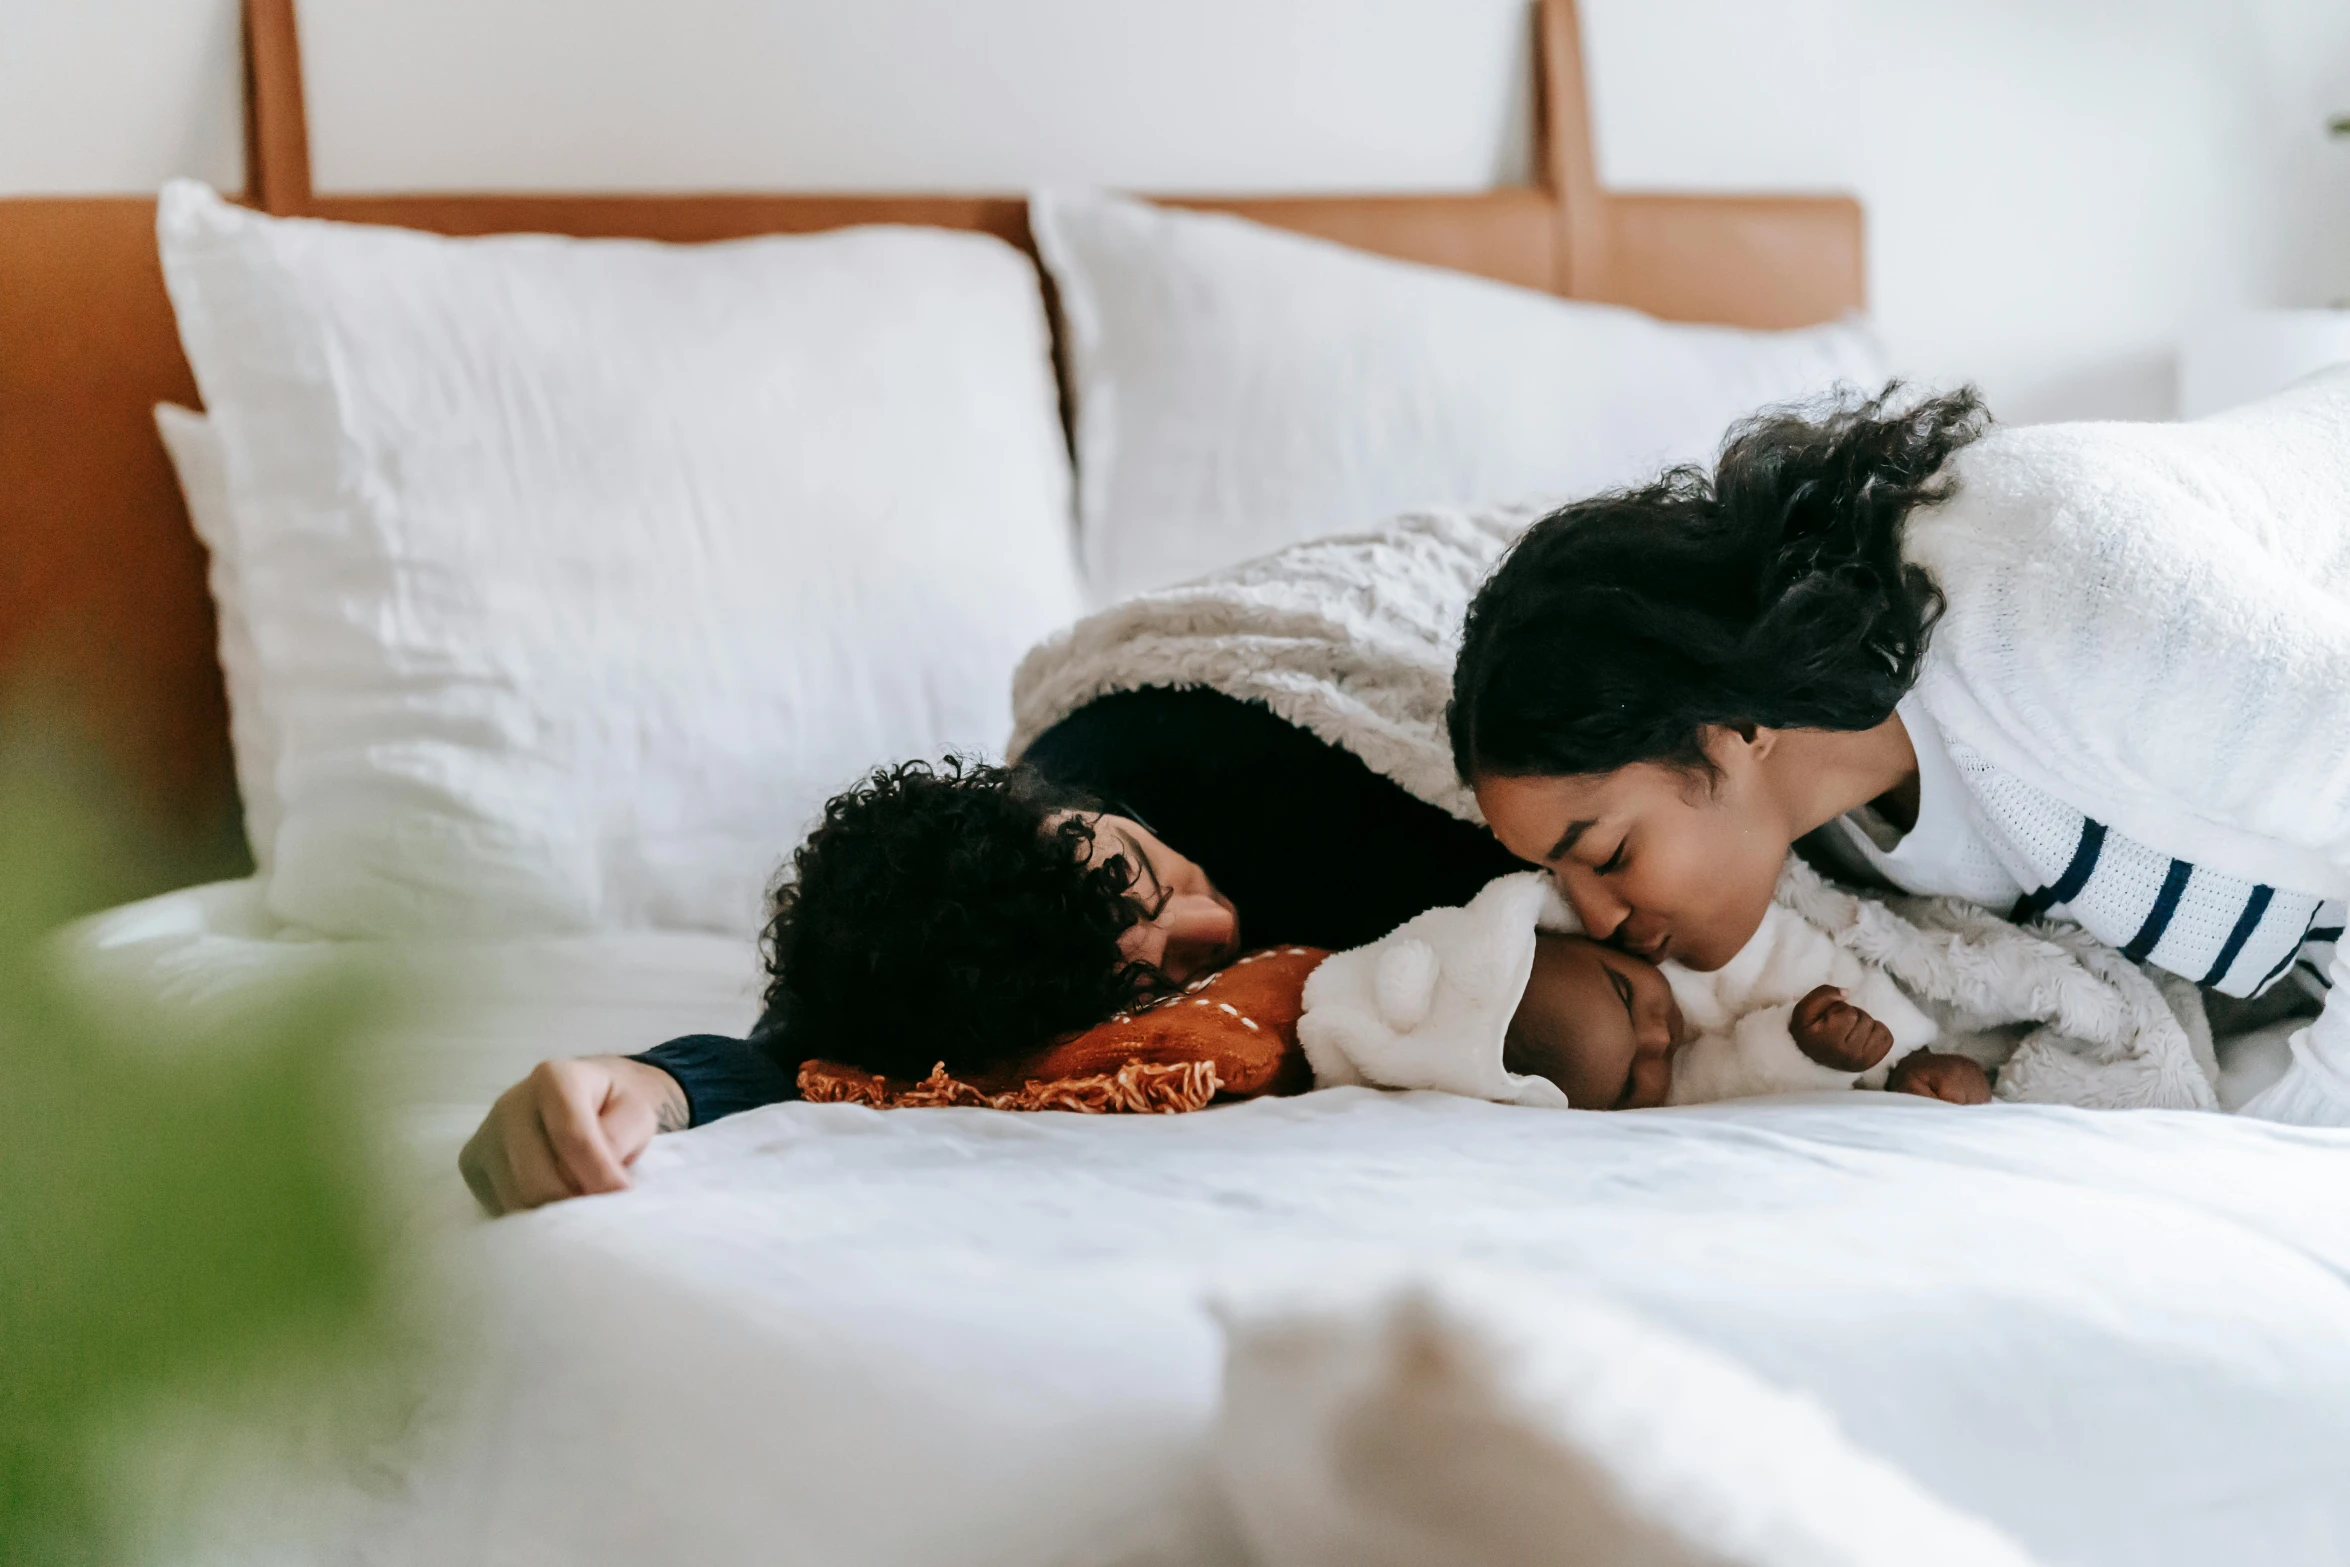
[1011,505,2216,1109]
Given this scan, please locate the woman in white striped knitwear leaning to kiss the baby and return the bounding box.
[1448,378,2350,1125]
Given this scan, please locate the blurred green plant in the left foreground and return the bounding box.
[0,712,390,1567]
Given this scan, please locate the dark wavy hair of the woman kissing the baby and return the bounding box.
[1445,383,1990,780]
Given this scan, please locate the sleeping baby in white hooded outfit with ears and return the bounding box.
[1297,872,1990,1109]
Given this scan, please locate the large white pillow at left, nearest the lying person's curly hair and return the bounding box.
[157,181,1079,935]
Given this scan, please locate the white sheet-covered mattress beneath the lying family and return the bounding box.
[68,890,2350,1567]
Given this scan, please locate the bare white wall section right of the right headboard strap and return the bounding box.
[1584,0,2350,421]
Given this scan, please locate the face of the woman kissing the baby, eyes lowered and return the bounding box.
[1476,731,1788,968]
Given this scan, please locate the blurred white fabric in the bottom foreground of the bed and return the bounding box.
[1217,1271,2028,1567]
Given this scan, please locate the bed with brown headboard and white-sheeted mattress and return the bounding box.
[18,0,2350,1562]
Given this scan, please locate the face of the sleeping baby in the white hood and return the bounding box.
[1502,935,1690,1109]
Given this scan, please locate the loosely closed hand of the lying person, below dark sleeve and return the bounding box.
[458,1055,689,1215]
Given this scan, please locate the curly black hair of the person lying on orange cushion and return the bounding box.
[757,756,1166,1078]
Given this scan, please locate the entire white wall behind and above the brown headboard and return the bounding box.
[0,0,2350,418]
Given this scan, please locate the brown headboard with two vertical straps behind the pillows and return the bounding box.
[0,0,1864,886]
